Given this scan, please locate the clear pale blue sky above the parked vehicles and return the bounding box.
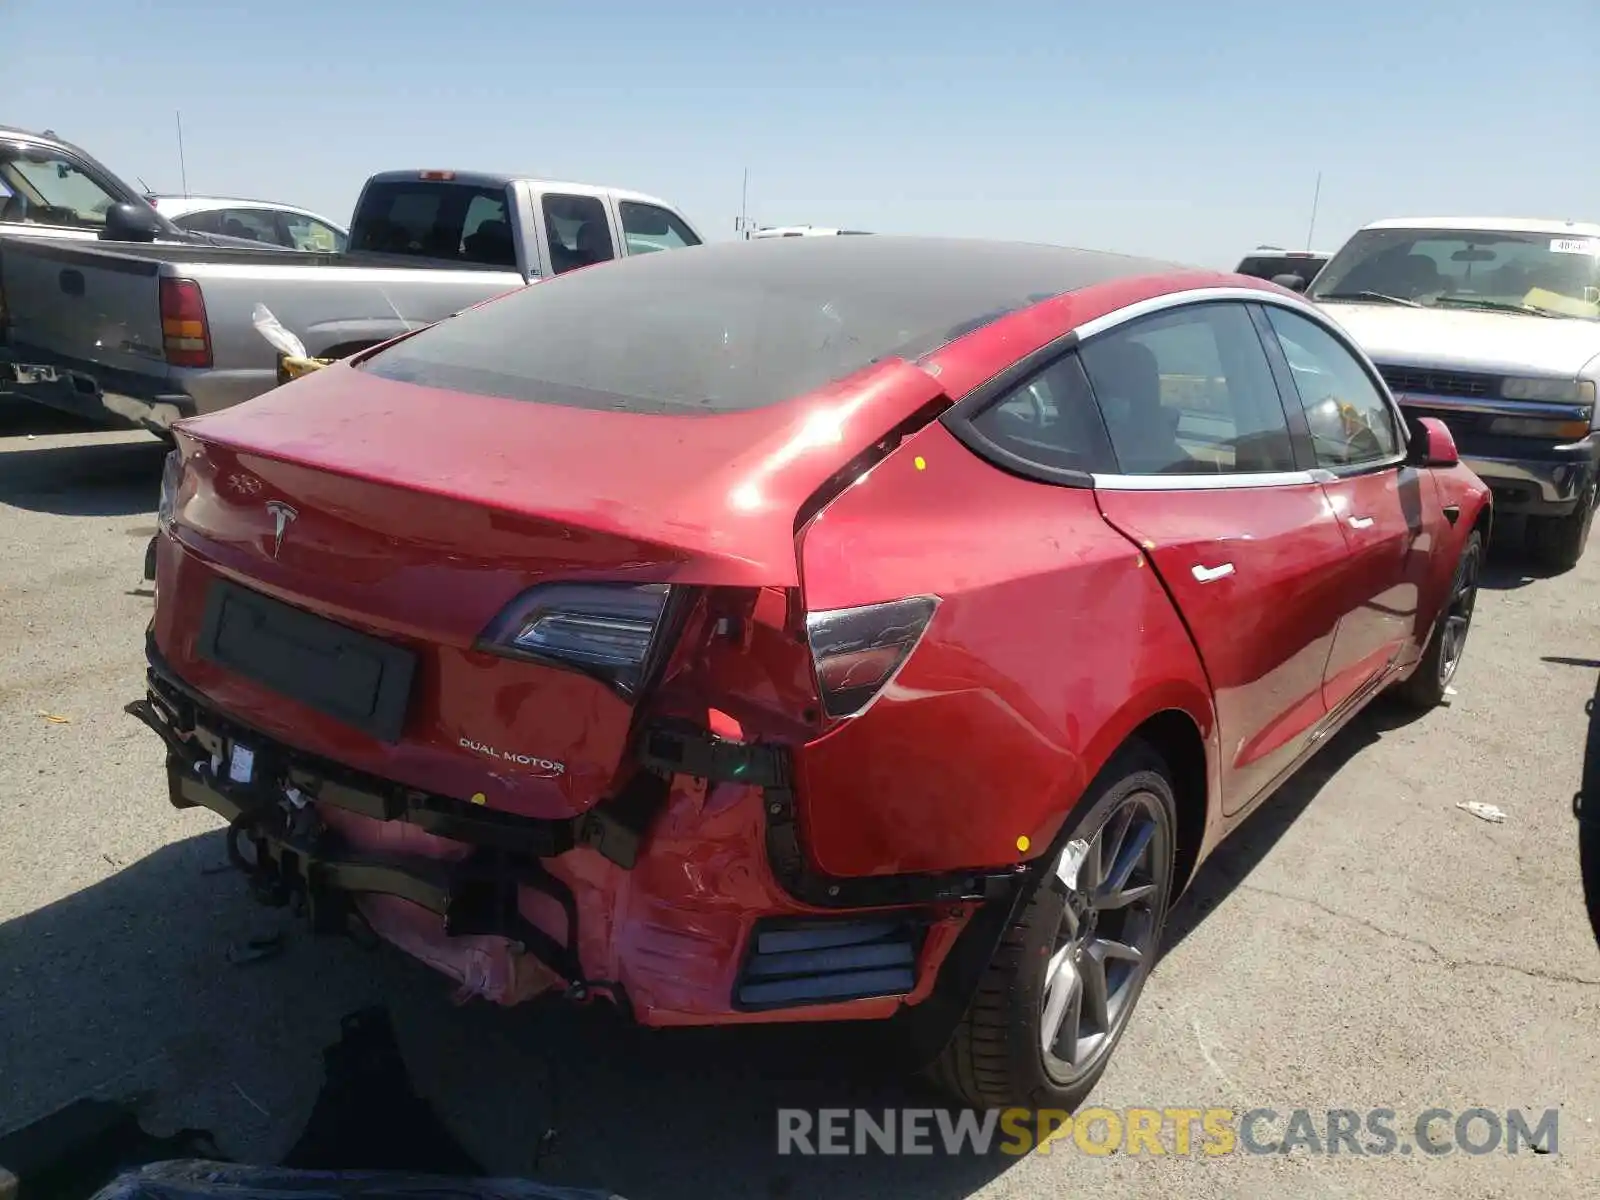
[0,0,1600,266]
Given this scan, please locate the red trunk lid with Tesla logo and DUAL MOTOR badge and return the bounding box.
[157,360,942,816]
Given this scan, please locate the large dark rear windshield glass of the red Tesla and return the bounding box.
[362,237,1142,413]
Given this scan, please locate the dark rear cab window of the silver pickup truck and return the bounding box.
[350,179,517,267]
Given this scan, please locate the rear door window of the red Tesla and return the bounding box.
[1080,304,1296,475]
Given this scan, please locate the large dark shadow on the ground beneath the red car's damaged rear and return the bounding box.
[0,832,1014,1200]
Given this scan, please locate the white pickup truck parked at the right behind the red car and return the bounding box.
[1307,218,1600,571]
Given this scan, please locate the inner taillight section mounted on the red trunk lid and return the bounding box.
[477,584,670,696]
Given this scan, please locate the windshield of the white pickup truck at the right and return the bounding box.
[1309,229,1600,320]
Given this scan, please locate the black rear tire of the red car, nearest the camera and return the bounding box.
[926,742,1178,1110]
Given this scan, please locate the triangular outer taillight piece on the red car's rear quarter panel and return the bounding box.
[805,595,939,717]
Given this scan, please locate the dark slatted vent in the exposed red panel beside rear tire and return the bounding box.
[733,917,922,1010]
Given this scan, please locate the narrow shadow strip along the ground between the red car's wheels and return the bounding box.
[1162,698,1422,955]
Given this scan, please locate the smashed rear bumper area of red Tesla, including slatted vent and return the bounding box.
[128,643,1027,1053]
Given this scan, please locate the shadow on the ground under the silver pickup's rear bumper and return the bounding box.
[0,434,166,517]
